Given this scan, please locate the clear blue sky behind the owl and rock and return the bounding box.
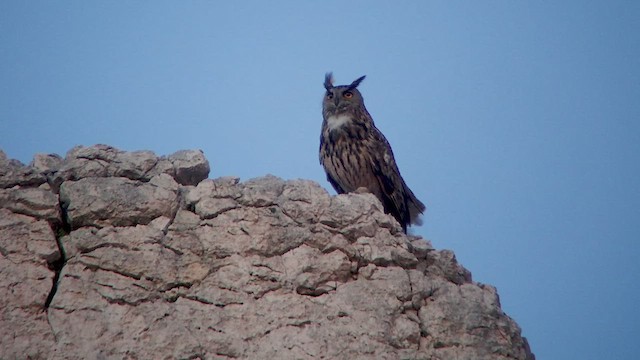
[0,0,640,360]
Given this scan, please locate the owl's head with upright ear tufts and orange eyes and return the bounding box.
[322,73,365,116]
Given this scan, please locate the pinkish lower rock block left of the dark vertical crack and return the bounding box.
[0,209,60,359]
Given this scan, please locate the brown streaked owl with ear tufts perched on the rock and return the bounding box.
[320,73,425,233]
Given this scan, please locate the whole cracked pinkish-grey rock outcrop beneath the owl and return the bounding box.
[0,145,534,359]
